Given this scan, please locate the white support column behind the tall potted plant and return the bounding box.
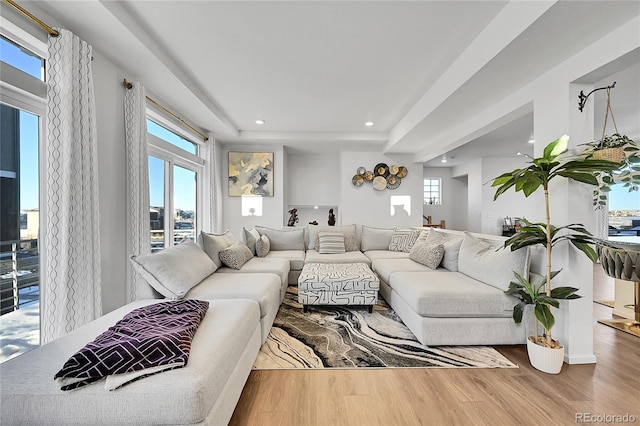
[534,81,596,364]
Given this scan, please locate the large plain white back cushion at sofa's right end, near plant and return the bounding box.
[458,232,529,291]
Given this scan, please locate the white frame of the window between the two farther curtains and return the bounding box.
[147,112,205,248]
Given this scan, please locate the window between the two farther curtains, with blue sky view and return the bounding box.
[147,119,204,252]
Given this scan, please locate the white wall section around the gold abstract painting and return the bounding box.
[220,144,287,240]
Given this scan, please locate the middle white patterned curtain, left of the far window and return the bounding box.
[124,83,153,302]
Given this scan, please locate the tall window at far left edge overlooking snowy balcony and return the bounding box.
[0,25,46,362]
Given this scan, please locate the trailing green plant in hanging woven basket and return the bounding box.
[581,133,640,208]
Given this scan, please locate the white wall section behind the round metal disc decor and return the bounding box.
[340,150,423,228]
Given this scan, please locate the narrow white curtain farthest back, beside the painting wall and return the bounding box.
[201,135,222,233]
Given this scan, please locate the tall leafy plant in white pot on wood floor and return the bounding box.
[492,135,618,374]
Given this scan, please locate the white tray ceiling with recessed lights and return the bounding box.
[22,0,640,159]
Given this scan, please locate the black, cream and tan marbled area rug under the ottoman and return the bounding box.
[253,287,517,370]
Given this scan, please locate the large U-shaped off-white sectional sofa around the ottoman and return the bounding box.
[0,225,530,424]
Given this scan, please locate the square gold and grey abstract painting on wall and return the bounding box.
[229,151,273,197]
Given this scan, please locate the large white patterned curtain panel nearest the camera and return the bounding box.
[41,30,102,343]
